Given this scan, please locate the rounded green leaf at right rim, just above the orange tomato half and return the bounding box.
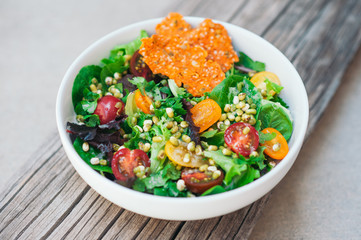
[258,100,293,141]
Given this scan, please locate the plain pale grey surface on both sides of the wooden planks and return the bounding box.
[0,0,361,239]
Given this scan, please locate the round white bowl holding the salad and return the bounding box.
[56,17,309,220]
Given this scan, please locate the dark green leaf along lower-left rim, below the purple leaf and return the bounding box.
[73,137,113,173]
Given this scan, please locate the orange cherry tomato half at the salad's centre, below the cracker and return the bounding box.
[190,99,222,132]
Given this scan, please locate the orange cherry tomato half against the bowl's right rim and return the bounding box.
[261,128,288,160]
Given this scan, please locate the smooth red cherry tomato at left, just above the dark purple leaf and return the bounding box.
[94,96,124,124]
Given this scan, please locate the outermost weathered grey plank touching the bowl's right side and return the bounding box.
[293,0,361,134]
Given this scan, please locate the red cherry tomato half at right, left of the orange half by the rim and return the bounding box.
[224,122,259,157]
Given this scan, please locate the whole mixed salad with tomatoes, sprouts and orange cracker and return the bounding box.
[67,13,293,197]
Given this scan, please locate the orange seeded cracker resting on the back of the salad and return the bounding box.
[139,13,238,96]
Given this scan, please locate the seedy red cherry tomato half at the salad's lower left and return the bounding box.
[112,148,150,181]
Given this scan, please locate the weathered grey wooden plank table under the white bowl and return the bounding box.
[0,0,361,239]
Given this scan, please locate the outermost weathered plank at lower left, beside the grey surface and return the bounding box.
[0,145,74,238]
